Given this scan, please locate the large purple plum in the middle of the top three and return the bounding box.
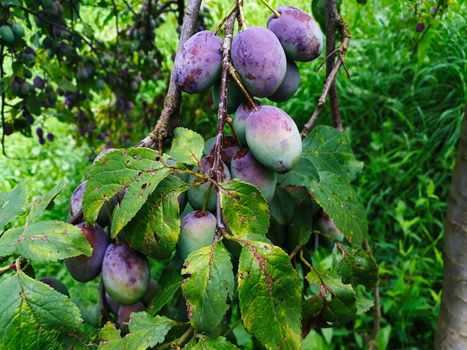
[232,27,287,97]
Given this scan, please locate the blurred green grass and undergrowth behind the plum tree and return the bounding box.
[0,0,467,349]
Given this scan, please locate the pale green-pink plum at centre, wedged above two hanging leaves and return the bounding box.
[178,210,216,259]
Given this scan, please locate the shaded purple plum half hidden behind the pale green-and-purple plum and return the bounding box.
[230,150,277,202]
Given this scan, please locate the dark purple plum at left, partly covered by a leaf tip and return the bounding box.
[65,223,109,282]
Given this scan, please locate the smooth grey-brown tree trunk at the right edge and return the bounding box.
[435,113,467,350]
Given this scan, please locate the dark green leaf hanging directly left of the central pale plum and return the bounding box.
[124,176,187,259]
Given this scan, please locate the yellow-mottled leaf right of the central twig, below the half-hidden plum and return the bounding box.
[220,180,269,236]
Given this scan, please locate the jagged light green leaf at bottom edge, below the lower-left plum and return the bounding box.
[99,312,176,350]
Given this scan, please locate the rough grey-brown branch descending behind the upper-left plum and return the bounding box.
[138,0,205,151]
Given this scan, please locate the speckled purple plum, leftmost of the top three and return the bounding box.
[173,30,223,94]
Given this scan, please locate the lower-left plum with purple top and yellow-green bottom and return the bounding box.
[102,242,150,305]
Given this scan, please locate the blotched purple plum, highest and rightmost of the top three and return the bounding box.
[268,6,323,62]
